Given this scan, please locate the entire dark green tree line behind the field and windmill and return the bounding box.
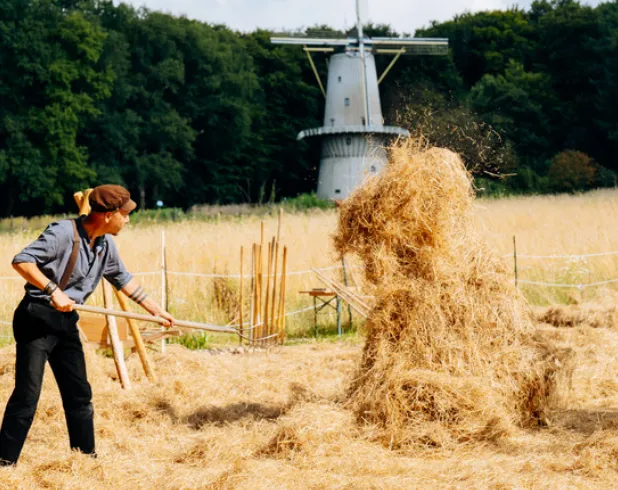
[0,0,618,216]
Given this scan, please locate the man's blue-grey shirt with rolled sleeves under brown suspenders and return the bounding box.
[13,219,132,303]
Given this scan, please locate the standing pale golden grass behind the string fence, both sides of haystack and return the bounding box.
[0,190,618,336]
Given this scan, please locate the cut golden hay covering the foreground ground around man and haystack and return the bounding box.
[0,327,618,490]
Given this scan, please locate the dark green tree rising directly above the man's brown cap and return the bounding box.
[83,2,195,207]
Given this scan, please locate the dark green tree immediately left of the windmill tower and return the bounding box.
[238,31,325,200]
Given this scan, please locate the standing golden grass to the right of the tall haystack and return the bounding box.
[476,189,618,304]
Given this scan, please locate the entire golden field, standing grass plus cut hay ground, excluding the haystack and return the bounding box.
[0,187,618,489]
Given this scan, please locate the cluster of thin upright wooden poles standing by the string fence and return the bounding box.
[238,209,288,344]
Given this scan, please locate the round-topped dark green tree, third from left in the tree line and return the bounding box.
[177,20,259,205]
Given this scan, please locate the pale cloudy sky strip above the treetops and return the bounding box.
[114,0,600,34]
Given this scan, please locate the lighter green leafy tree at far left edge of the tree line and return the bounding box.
[0,0,113,216]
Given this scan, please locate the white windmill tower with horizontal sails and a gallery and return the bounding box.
[271,0,448,199]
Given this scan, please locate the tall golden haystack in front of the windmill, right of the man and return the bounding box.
[334,141,560,447]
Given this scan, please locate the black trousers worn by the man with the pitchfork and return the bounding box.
[0,300,94,464]
